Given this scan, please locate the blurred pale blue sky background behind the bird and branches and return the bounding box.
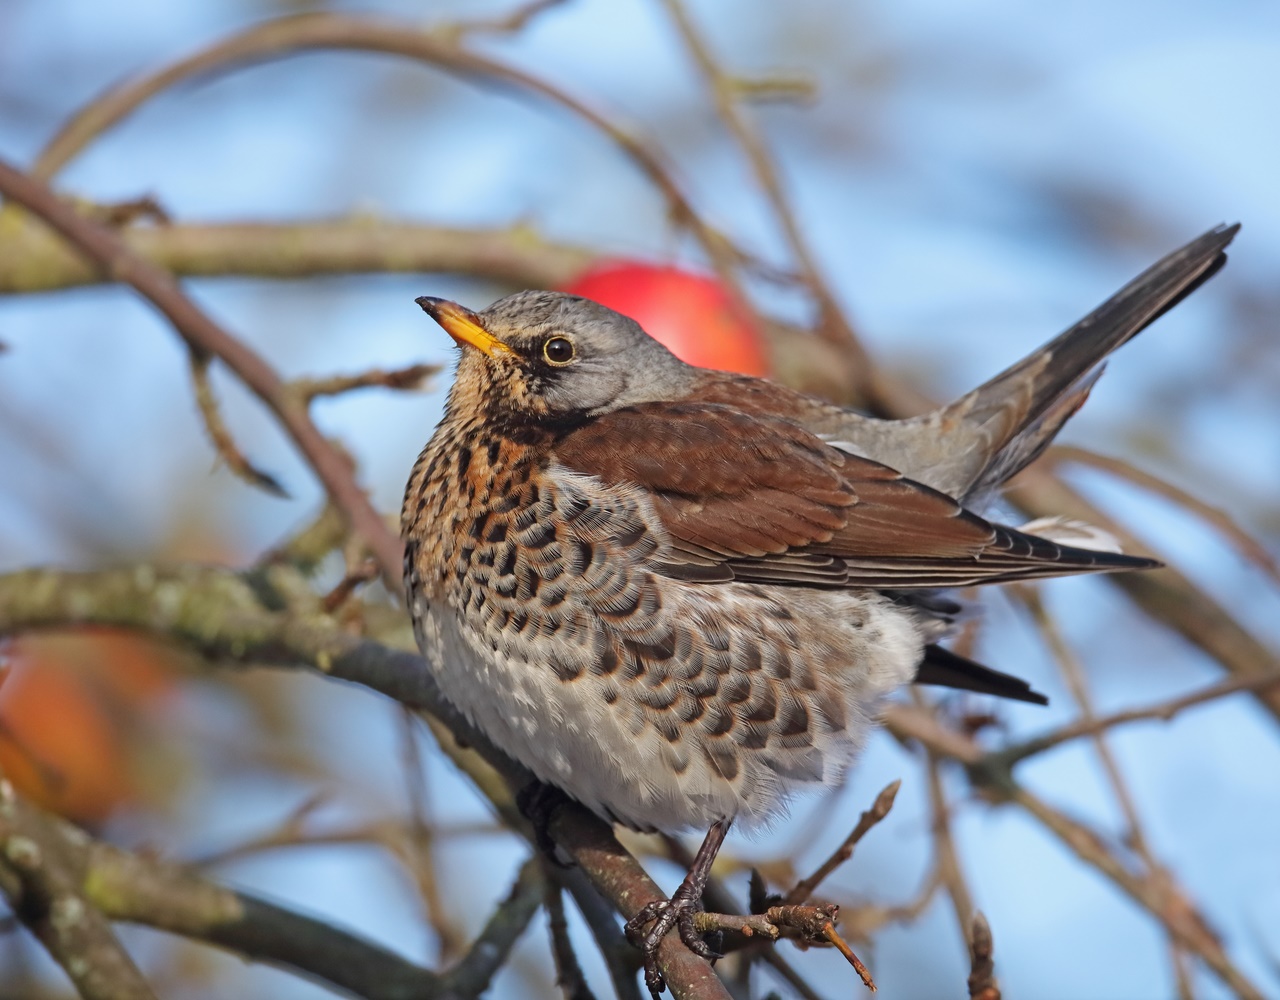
[0,0,1280,1000]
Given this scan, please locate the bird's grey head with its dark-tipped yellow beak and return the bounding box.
[417,292,698,419]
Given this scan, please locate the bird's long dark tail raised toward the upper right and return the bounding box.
[947,224,1240,496]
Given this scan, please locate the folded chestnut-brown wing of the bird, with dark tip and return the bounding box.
[554,402,1155,589]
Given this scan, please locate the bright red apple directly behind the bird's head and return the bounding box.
[561,260,769,376]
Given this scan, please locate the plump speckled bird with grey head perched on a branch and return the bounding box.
[401,225,1239,997]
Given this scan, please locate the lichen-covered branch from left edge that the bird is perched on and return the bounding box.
[0,567,728,1000]
